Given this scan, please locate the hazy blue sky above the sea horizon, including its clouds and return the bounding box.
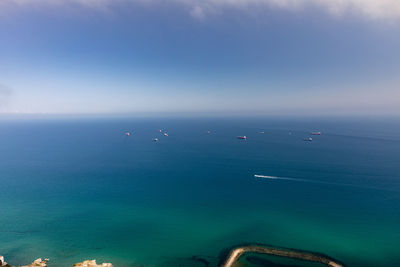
[0,0,400,115]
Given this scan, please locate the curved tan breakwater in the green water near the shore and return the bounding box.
[221,245,344,267]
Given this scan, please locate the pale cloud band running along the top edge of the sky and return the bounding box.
[0,0,400,20]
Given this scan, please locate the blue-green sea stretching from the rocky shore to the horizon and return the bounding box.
[0,117,400,267]
